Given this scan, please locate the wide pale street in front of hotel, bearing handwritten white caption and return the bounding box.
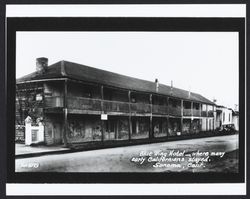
[16,135,238,172]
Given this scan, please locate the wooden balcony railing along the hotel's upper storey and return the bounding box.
[44,96,209,117]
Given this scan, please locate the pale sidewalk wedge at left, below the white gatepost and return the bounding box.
[15,143,71,158]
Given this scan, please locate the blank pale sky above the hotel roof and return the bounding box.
[16,32,239,108]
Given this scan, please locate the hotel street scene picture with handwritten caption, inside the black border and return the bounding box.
[15,31,239,173]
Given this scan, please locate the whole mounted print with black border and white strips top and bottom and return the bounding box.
[2,2,247,195]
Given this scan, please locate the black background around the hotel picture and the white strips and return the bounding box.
[0,0,249,198]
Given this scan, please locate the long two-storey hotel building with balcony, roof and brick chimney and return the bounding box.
[16,58,216,145]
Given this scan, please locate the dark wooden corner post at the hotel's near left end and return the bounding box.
[63,79,68,147]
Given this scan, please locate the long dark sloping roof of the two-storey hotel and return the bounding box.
[16,61,214,105]
